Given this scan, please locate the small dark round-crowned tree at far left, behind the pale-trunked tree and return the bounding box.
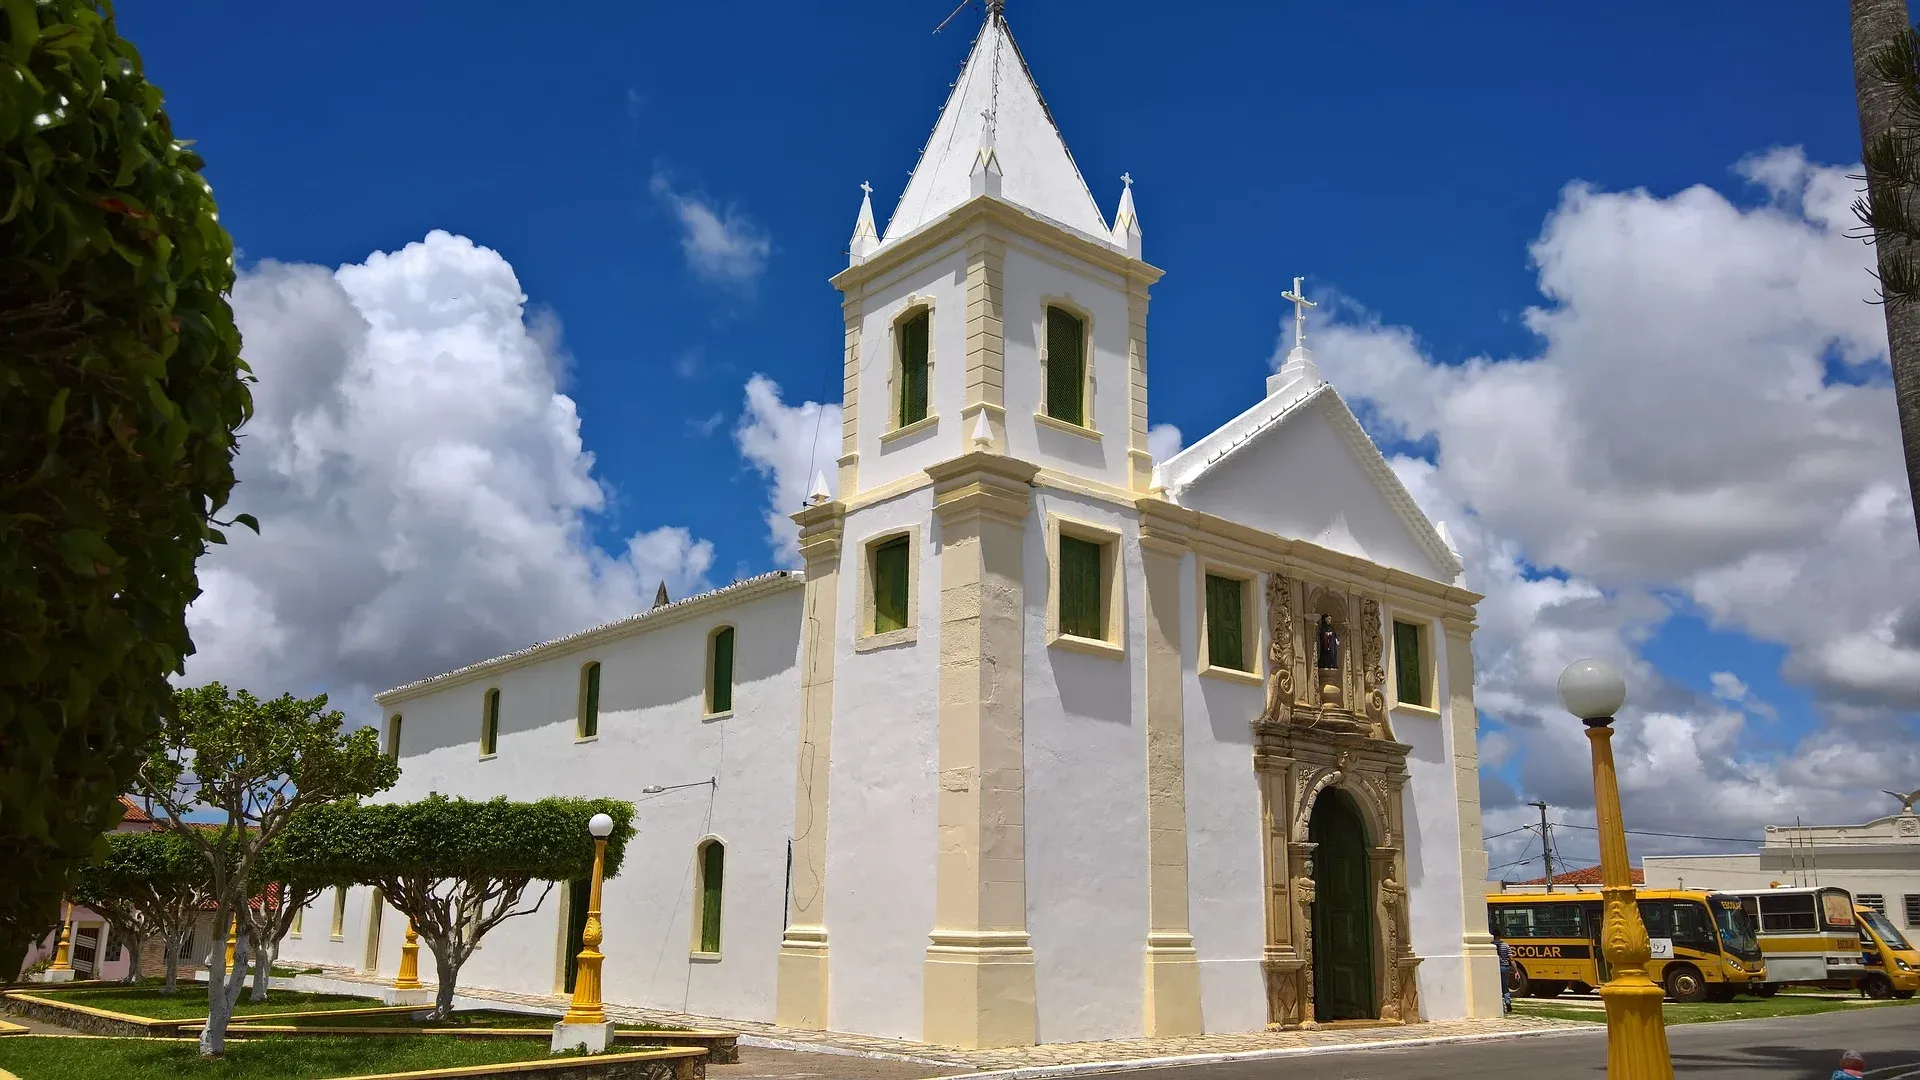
[71,832,207,990]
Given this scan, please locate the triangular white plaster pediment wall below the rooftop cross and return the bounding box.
[1181,398,1453,580]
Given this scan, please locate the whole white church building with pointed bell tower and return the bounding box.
[282,2,1500,1047]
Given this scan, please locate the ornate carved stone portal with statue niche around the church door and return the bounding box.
[1254,575,1421,1028]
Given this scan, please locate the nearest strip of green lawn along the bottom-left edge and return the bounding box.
[0,1030,602,1080]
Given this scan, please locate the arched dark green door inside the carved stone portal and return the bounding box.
[1308,788,1379,1020]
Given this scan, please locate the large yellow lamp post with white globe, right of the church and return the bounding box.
[1559,659,1674,1080]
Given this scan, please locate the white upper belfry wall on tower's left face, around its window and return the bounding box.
[860,240,966,498]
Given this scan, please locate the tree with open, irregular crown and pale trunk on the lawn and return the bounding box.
[136,682,399,1055]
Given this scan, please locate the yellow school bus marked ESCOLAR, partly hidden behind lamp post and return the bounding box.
[1486,890,1766,1001]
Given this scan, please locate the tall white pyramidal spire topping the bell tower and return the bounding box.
[881,2,1112,244]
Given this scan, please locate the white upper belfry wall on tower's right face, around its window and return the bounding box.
[1002,236,1131,488]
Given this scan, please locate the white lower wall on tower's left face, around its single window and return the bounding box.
[825,488,945,1040]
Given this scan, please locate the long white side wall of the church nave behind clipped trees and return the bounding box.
[284,578,803,1020]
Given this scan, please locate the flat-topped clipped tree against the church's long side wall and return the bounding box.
[286,796,634,1019]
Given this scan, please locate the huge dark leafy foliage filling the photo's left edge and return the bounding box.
[0,0,253,972]
